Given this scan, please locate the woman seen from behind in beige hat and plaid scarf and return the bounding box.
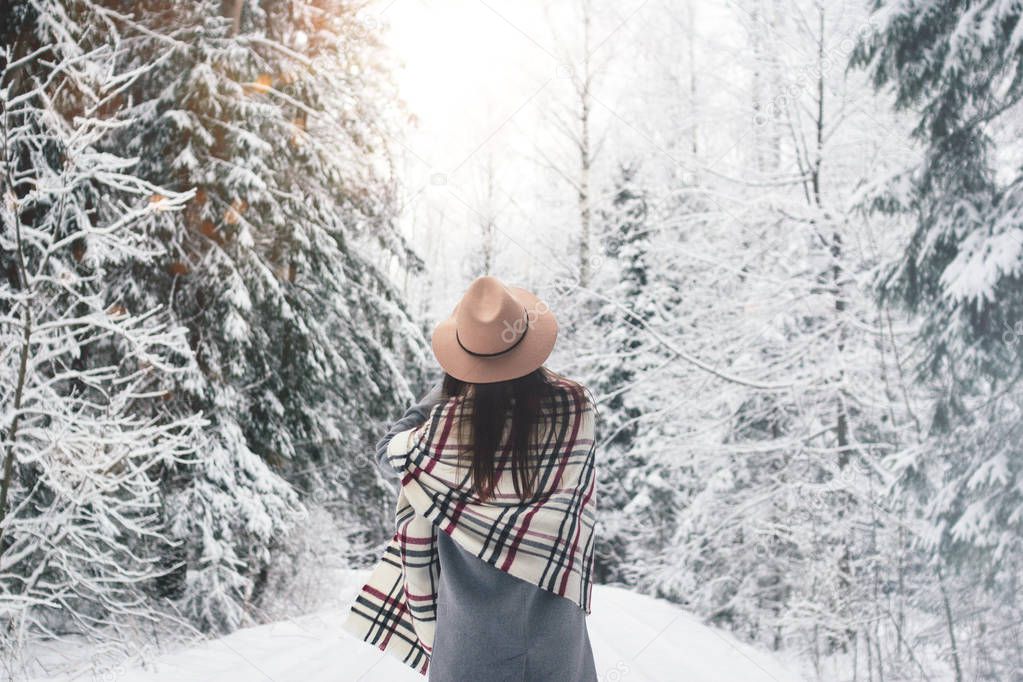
[345,276,596,682]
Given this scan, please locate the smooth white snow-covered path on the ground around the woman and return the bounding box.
[28,572,801,682]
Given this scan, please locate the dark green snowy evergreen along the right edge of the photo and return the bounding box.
[852,5,1023,679]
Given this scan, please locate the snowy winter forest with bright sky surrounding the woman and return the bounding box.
[0,0,1023,682]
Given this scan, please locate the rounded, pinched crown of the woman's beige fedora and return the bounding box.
[454,275,529,355]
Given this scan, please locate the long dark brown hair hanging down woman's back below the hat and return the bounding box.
[443,367,591,500]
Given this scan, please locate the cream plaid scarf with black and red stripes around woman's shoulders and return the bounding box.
[342,382,596,675]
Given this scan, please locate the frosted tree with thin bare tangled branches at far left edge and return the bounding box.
[0,0,202,654]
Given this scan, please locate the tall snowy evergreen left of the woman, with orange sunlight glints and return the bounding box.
[19,0,425,631]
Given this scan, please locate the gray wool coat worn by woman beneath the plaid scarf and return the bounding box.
[376,383,597,682]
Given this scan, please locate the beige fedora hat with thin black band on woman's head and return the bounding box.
[431,275,558,383]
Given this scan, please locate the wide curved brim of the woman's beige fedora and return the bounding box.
[430,286,558,383]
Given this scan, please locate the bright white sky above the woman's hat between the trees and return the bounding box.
[362,0,740,315]
